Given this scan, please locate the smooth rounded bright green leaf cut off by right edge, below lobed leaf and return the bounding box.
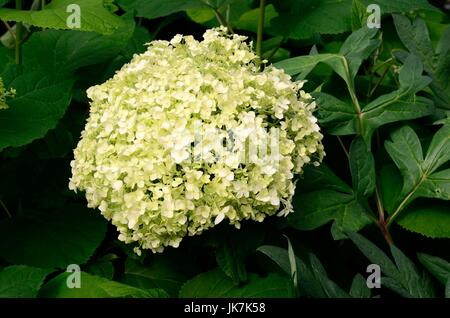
[396,201,450,238]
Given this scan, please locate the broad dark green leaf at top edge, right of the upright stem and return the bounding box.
[271,0,352,39]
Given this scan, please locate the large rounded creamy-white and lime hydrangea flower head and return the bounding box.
[69,28,324,253]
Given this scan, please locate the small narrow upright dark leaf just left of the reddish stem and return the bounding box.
[349,137,376,197]
